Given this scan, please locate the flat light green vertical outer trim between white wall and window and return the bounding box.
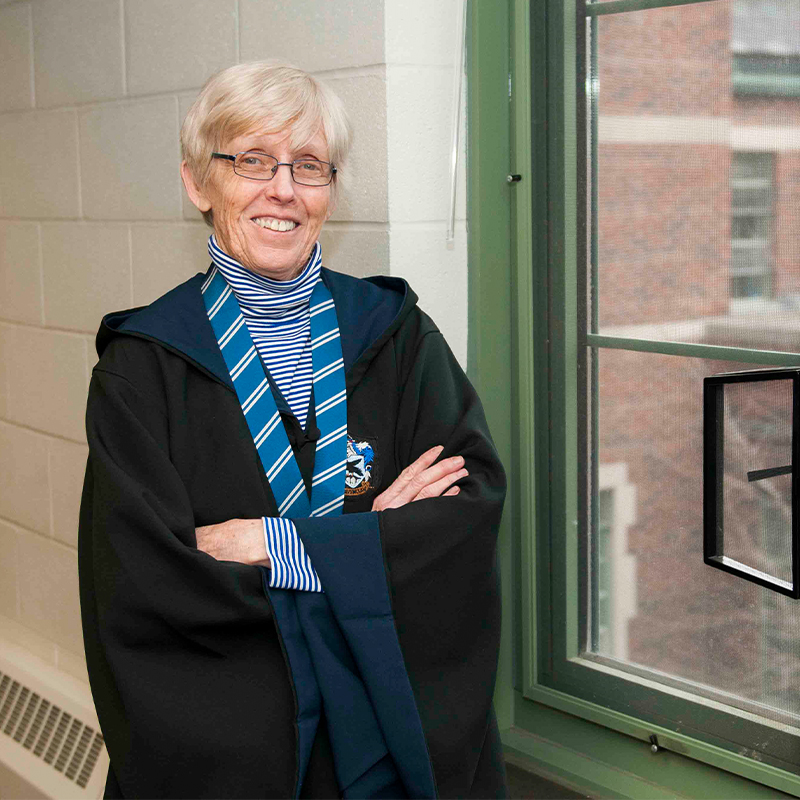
[467,0,515,726]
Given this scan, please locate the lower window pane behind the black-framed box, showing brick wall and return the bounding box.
[586,349,800,729]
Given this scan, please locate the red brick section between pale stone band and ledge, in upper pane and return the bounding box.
[598,144,730,326]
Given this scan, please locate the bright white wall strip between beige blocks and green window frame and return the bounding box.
[384,0,468,365]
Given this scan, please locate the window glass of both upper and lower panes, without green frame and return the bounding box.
[582,0,800,746]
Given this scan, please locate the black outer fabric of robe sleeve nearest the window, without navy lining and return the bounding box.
[379,331,506,797]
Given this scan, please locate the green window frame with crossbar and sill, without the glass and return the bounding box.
[467,0,800,798]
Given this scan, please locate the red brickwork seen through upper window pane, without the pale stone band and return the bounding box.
[598,2,800,326]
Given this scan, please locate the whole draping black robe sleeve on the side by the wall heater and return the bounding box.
[79,369,295,797]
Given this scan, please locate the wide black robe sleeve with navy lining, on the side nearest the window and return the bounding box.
[295,330,505,797]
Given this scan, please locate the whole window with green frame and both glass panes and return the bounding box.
[468,0,800,797]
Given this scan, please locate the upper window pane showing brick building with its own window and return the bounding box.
[590,0,800,352]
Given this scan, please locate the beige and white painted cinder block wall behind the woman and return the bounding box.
[0,0,466,692]
